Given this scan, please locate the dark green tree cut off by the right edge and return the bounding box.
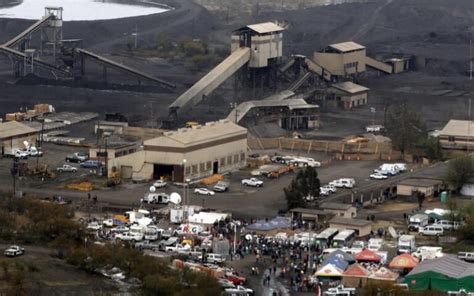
[444,155,474,192]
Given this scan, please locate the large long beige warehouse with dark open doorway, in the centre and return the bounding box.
[108,120,247,182]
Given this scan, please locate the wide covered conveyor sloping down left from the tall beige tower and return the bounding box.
[169,47,250,114]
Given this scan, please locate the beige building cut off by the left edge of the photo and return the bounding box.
[0,121,38,155]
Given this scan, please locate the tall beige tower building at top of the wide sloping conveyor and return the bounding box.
[231,22,284,68]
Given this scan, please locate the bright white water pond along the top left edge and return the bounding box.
[0,0,167,21]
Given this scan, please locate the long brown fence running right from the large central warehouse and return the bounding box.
[248,138,401,160]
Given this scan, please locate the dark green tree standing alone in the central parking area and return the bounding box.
[283,167,321,209]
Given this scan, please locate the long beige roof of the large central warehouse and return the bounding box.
[144,120,247,147]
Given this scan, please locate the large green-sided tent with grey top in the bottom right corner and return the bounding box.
[405,255,474,292]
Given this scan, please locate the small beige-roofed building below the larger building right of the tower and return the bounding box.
[328,81,369,109]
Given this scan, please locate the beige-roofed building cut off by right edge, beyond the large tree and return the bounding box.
[439,119,474,150]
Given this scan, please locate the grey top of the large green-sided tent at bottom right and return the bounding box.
[407,255,474,279]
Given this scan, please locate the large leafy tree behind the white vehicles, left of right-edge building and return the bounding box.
[385,104,426,154]
